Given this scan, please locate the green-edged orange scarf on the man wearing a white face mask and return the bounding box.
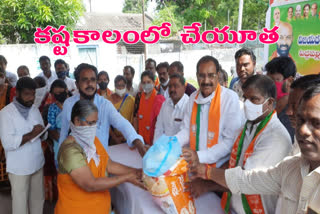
[221,111,276,214]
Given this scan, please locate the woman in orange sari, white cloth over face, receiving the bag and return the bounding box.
[55,100,143,214]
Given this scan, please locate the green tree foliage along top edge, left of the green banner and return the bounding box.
[153,0,269,33]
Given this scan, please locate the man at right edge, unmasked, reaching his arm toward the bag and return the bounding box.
[190,85,320,214]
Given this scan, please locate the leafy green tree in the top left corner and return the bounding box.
[0,0,84,43]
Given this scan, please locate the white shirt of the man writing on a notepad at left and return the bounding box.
[0,103,44,175]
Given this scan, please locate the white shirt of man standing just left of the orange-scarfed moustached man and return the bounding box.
[153,94,189,142]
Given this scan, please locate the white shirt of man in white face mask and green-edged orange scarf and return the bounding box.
[231,114,292,214]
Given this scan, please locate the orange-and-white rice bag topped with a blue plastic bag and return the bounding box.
[143,135,196,214]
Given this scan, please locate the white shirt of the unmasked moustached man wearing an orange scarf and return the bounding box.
[176,87,242,167]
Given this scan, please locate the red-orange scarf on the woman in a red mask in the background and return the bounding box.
[138,89,157,145]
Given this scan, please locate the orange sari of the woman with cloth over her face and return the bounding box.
[54,137,111,214]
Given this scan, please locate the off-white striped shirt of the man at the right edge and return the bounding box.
[225,153,320,214]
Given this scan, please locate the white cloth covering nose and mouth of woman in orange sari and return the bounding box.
[70,122,97,148]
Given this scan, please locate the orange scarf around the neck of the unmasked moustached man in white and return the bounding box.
[190,84,221,167]
